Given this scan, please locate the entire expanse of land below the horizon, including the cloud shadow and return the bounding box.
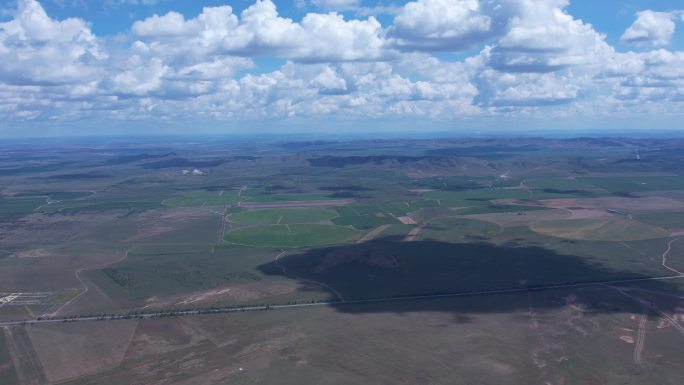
[0,138,684,385]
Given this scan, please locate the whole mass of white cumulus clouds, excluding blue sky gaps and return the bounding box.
[0,0,684,125]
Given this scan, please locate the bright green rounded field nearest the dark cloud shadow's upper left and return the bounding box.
[225,224,359,247]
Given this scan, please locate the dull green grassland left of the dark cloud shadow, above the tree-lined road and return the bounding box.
[88,245,329,309]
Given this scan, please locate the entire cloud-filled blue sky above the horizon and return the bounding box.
[0,0,684,137]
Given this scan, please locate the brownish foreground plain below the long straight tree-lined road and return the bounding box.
[41,288,680,385]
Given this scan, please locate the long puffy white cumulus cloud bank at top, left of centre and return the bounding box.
[133,0,386,62]
